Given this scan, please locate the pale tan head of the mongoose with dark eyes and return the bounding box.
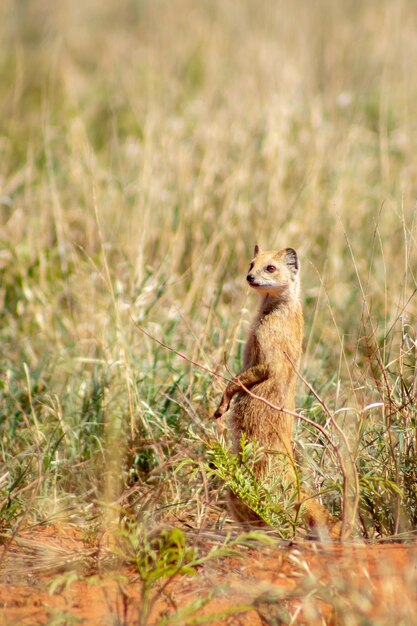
[246,246,300,297]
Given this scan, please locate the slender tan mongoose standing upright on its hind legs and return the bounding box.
[214,246,336,528]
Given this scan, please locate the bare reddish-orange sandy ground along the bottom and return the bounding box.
[0,526,417,626]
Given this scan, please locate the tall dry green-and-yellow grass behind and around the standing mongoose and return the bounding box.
[0,0,417,623]
